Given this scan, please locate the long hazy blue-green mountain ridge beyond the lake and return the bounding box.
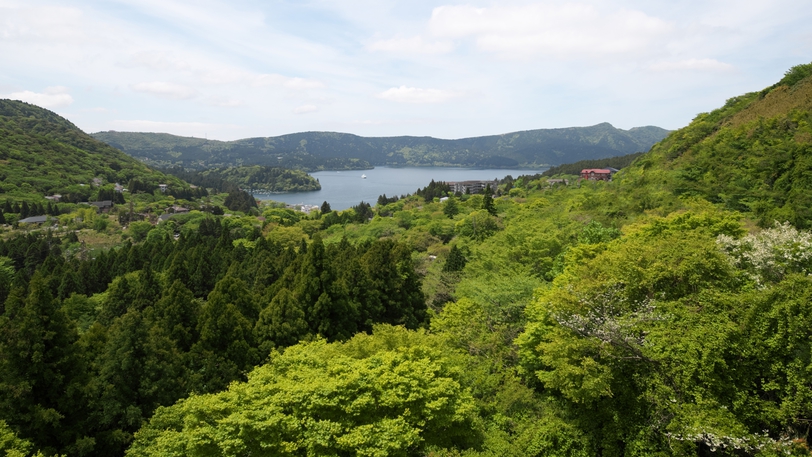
[93,123,669,171]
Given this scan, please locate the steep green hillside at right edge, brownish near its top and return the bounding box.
[602,63,812,228]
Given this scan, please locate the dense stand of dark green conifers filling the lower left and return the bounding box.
[0,221,426,455]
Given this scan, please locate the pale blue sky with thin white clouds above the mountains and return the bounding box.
[0,0,812,140]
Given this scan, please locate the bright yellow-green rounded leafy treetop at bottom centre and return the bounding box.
[127,329,478,457]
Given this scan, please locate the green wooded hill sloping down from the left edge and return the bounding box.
[0,100,188,199]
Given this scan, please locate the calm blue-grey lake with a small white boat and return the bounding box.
[255,167,546,210]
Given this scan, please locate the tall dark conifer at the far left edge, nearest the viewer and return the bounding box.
[0,274,86,453]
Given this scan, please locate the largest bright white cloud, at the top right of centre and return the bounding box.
[429,3,674,57]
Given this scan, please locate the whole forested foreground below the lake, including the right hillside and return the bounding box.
[0,64,812,457]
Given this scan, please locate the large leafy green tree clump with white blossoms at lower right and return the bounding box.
[519,212,812,456]
